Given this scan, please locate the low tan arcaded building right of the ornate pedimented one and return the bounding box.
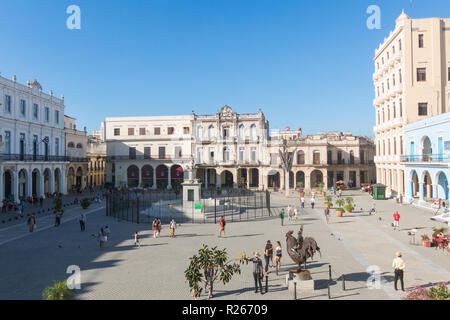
[265,128,376,190]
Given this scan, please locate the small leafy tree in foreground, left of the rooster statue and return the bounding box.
[184,244,246,297]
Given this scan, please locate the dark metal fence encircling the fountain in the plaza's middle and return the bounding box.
[106,189,273,224]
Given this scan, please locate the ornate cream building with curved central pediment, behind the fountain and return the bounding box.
[193,106,269,188]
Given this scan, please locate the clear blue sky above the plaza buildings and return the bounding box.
[0,0,450,136]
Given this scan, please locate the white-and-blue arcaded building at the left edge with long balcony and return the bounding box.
[0,76,66,201]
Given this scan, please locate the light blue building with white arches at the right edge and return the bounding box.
[402,112,450,204]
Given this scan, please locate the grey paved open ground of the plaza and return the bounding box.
[0,190,450,300]
